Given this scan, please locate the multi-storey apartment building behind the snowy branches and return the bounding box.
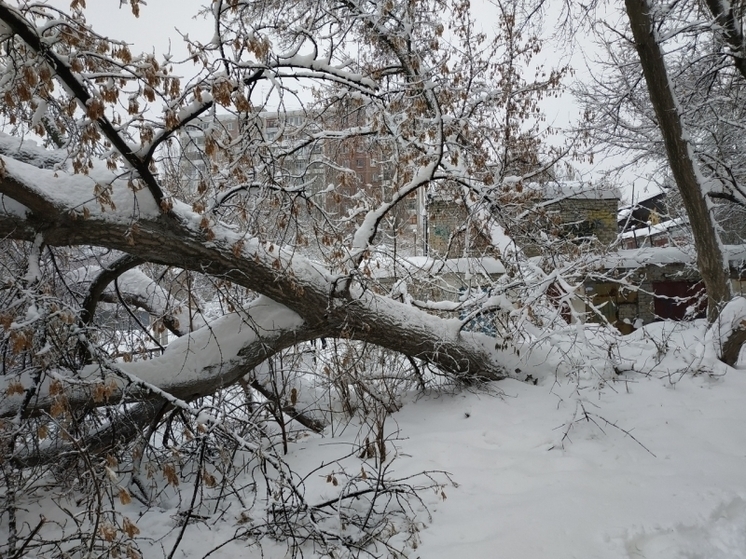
[179,106,418,250]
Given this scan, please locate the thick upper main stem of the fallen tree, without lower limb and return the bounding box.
[0,152,506,394]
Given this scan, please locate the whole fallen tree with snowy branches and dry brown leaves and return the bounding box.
[0,1,561,424]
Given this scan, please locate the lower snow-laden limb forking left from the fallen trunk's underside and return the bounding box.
[0,297,318,417]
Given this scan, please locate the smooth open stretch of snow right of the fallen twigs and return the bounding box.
[406,373,746,559]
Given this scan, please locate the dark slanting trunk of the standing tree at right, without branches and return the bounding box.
[625,0,732,323]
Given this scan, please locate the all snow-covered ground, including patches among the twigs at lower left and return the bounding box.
[2,324,746,559]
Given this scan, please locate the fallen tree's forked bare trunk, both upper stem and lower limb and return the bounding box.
[0,153,508,417]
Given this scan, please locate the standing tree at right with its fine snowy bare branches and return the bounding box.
[579,1,746,363]
